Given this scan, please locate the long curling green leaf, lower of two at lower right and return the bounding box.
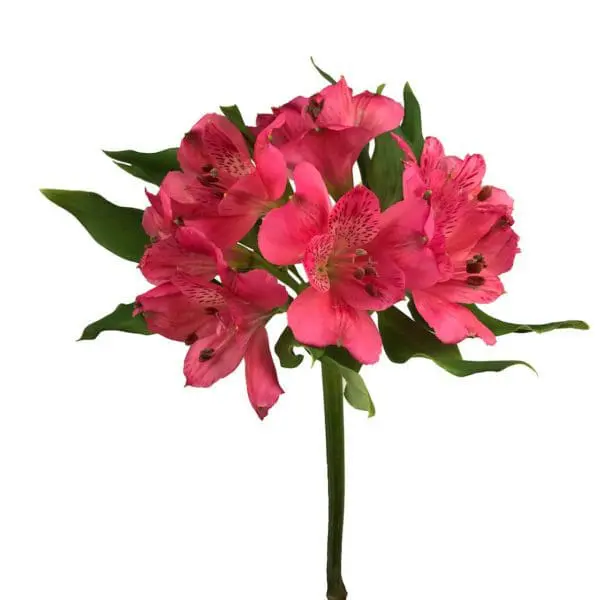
[378,306,535,377]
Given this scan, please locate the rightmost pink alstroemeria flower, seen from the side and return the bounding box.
[397,138,519,344]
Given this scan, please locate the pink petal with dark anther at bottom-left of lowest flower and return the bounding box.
[183,328,251,387]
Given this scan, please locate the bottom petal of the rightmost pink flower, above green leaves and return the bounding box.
[413,292,496,345]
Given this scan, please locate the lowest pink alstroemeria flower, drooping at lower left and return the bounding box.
[137,270,288,419]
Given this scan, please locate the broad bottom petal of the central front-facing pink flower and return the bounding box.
[288,288,381,364]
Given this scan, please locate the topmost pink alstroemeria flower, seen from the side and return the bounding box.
[255,77,404,197]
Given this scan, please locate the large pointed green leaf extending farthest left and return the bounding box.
[40,189,148,262]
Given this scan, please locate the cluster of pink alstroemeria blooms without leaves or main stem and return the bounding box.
[136,78,518,418]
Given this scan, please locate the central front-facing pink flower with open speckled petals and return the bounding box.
[258,163,439,364]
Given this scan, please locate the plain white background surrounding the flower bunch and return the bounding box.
[0,0,600,600]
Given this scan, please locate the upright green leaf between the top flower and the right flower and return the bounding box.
[363,133,404,209]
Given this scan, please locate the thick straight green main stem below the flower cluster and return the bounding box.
[321,361,348,600]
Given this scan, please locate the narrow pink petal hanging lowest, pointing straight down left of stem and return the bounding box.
[244,327,283,419]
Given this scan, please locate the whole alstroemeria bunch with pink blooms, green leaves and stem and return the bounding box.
[42,59,587,600]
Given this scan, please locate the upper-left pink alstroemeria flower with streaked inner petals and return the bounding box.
[144,114,287,248]
